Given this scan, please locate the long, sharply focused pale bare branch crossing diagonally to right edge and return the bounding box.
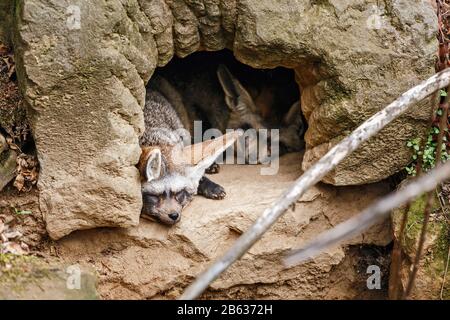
[180,69,450,299]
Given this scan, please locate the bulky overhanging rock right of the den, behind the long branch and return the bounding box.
[234,0,437,185]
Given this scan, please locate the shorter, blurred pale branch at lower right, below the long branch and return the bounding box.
[285,162,450,266]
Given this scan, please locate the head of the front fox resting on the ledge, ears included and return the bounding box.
[138,132,240,225]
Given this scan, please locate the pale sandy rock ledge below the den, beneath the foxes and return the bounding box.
[55,154,391,299]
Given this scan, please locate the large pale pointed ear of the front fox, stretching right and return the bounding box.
[183,130,242,178]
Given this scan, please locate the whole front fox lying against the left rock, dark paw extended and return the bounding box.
[139,89,238,225]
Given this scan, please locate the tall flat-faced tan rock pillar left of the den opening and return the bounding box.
[15,0,156,239]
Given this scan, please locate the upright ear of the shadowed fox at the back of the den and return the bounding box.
[217,64,257,116]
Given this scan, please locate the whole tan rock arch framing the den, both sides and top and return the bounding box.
[7,0,437,238]
